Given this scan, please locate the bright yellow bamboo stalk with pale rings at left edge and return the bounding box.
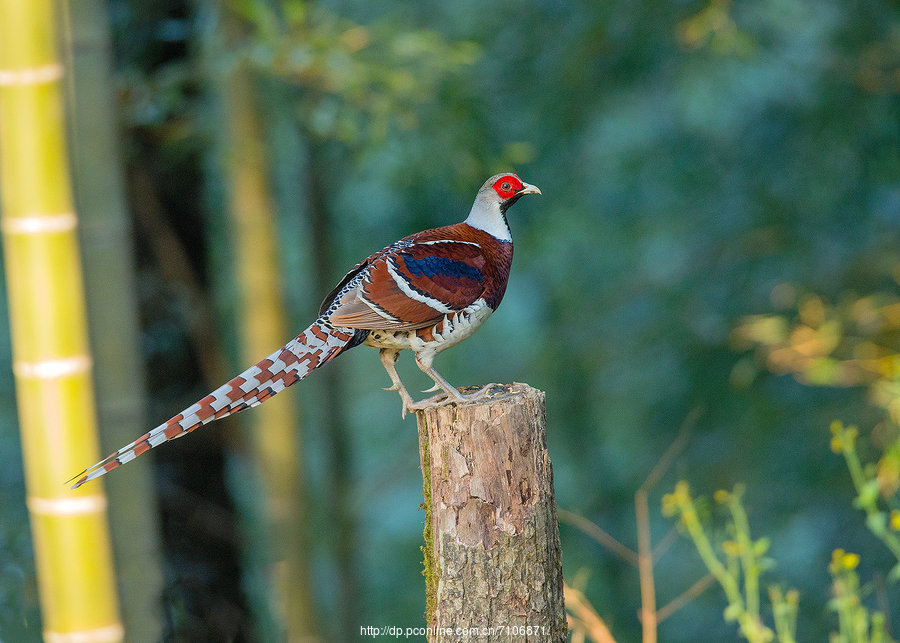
[0,0,123,643]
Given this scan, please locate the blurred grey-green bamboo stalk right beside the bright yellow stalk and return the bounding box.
[67,0,163,639]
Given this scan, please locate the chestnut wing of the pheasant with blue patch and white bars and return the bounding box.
[329,238,487,330]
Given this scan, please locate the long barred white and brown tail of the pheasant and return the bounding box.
[69,318,360,489]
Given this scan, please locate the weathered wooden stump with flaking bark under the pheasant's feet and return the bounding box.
[417,383,566,643]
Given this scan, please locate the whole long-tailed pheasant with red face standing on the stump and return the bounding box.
[69,173,541,489]
